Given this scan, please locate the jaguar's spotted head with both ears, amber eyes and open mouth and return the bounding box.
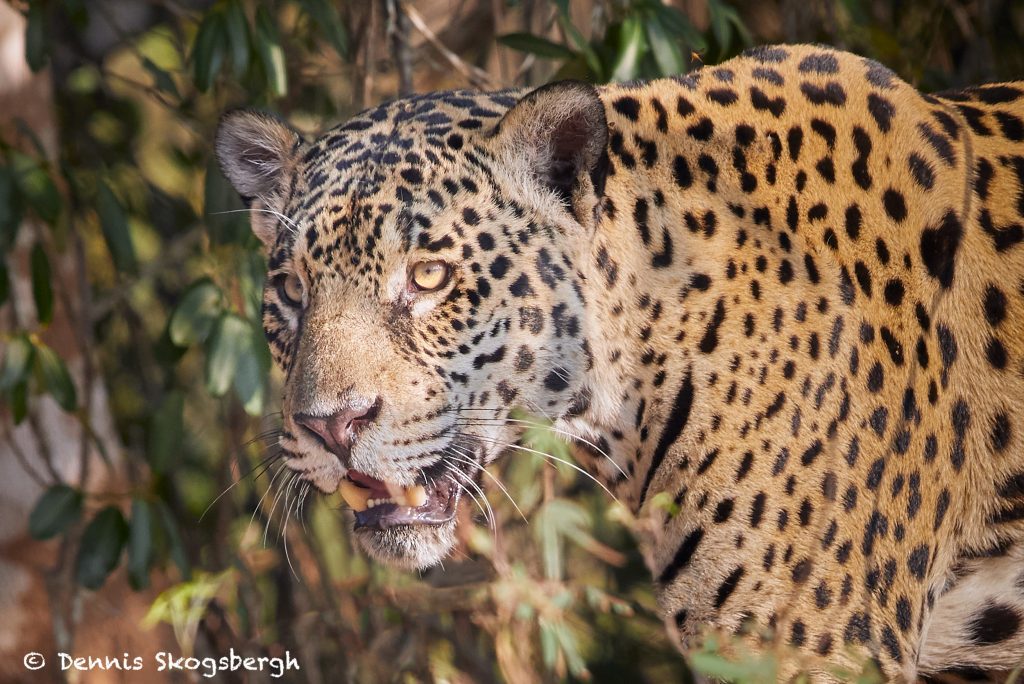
[210,84,606,568]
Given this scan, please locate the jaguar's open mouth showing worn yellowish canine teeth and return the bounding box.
[338,470,459,529]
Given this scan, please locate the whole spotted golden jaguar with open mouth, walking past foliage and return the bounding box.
[215,45,1024,681]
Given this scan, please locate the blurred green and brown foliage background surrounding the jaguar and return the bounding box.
[0,0,1024,684]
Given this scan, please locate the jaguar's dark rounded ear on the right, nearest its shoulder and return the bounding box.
[496,81,608,224]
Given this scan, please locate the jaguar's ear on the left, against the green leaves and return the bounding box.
[214,110,302,247]
